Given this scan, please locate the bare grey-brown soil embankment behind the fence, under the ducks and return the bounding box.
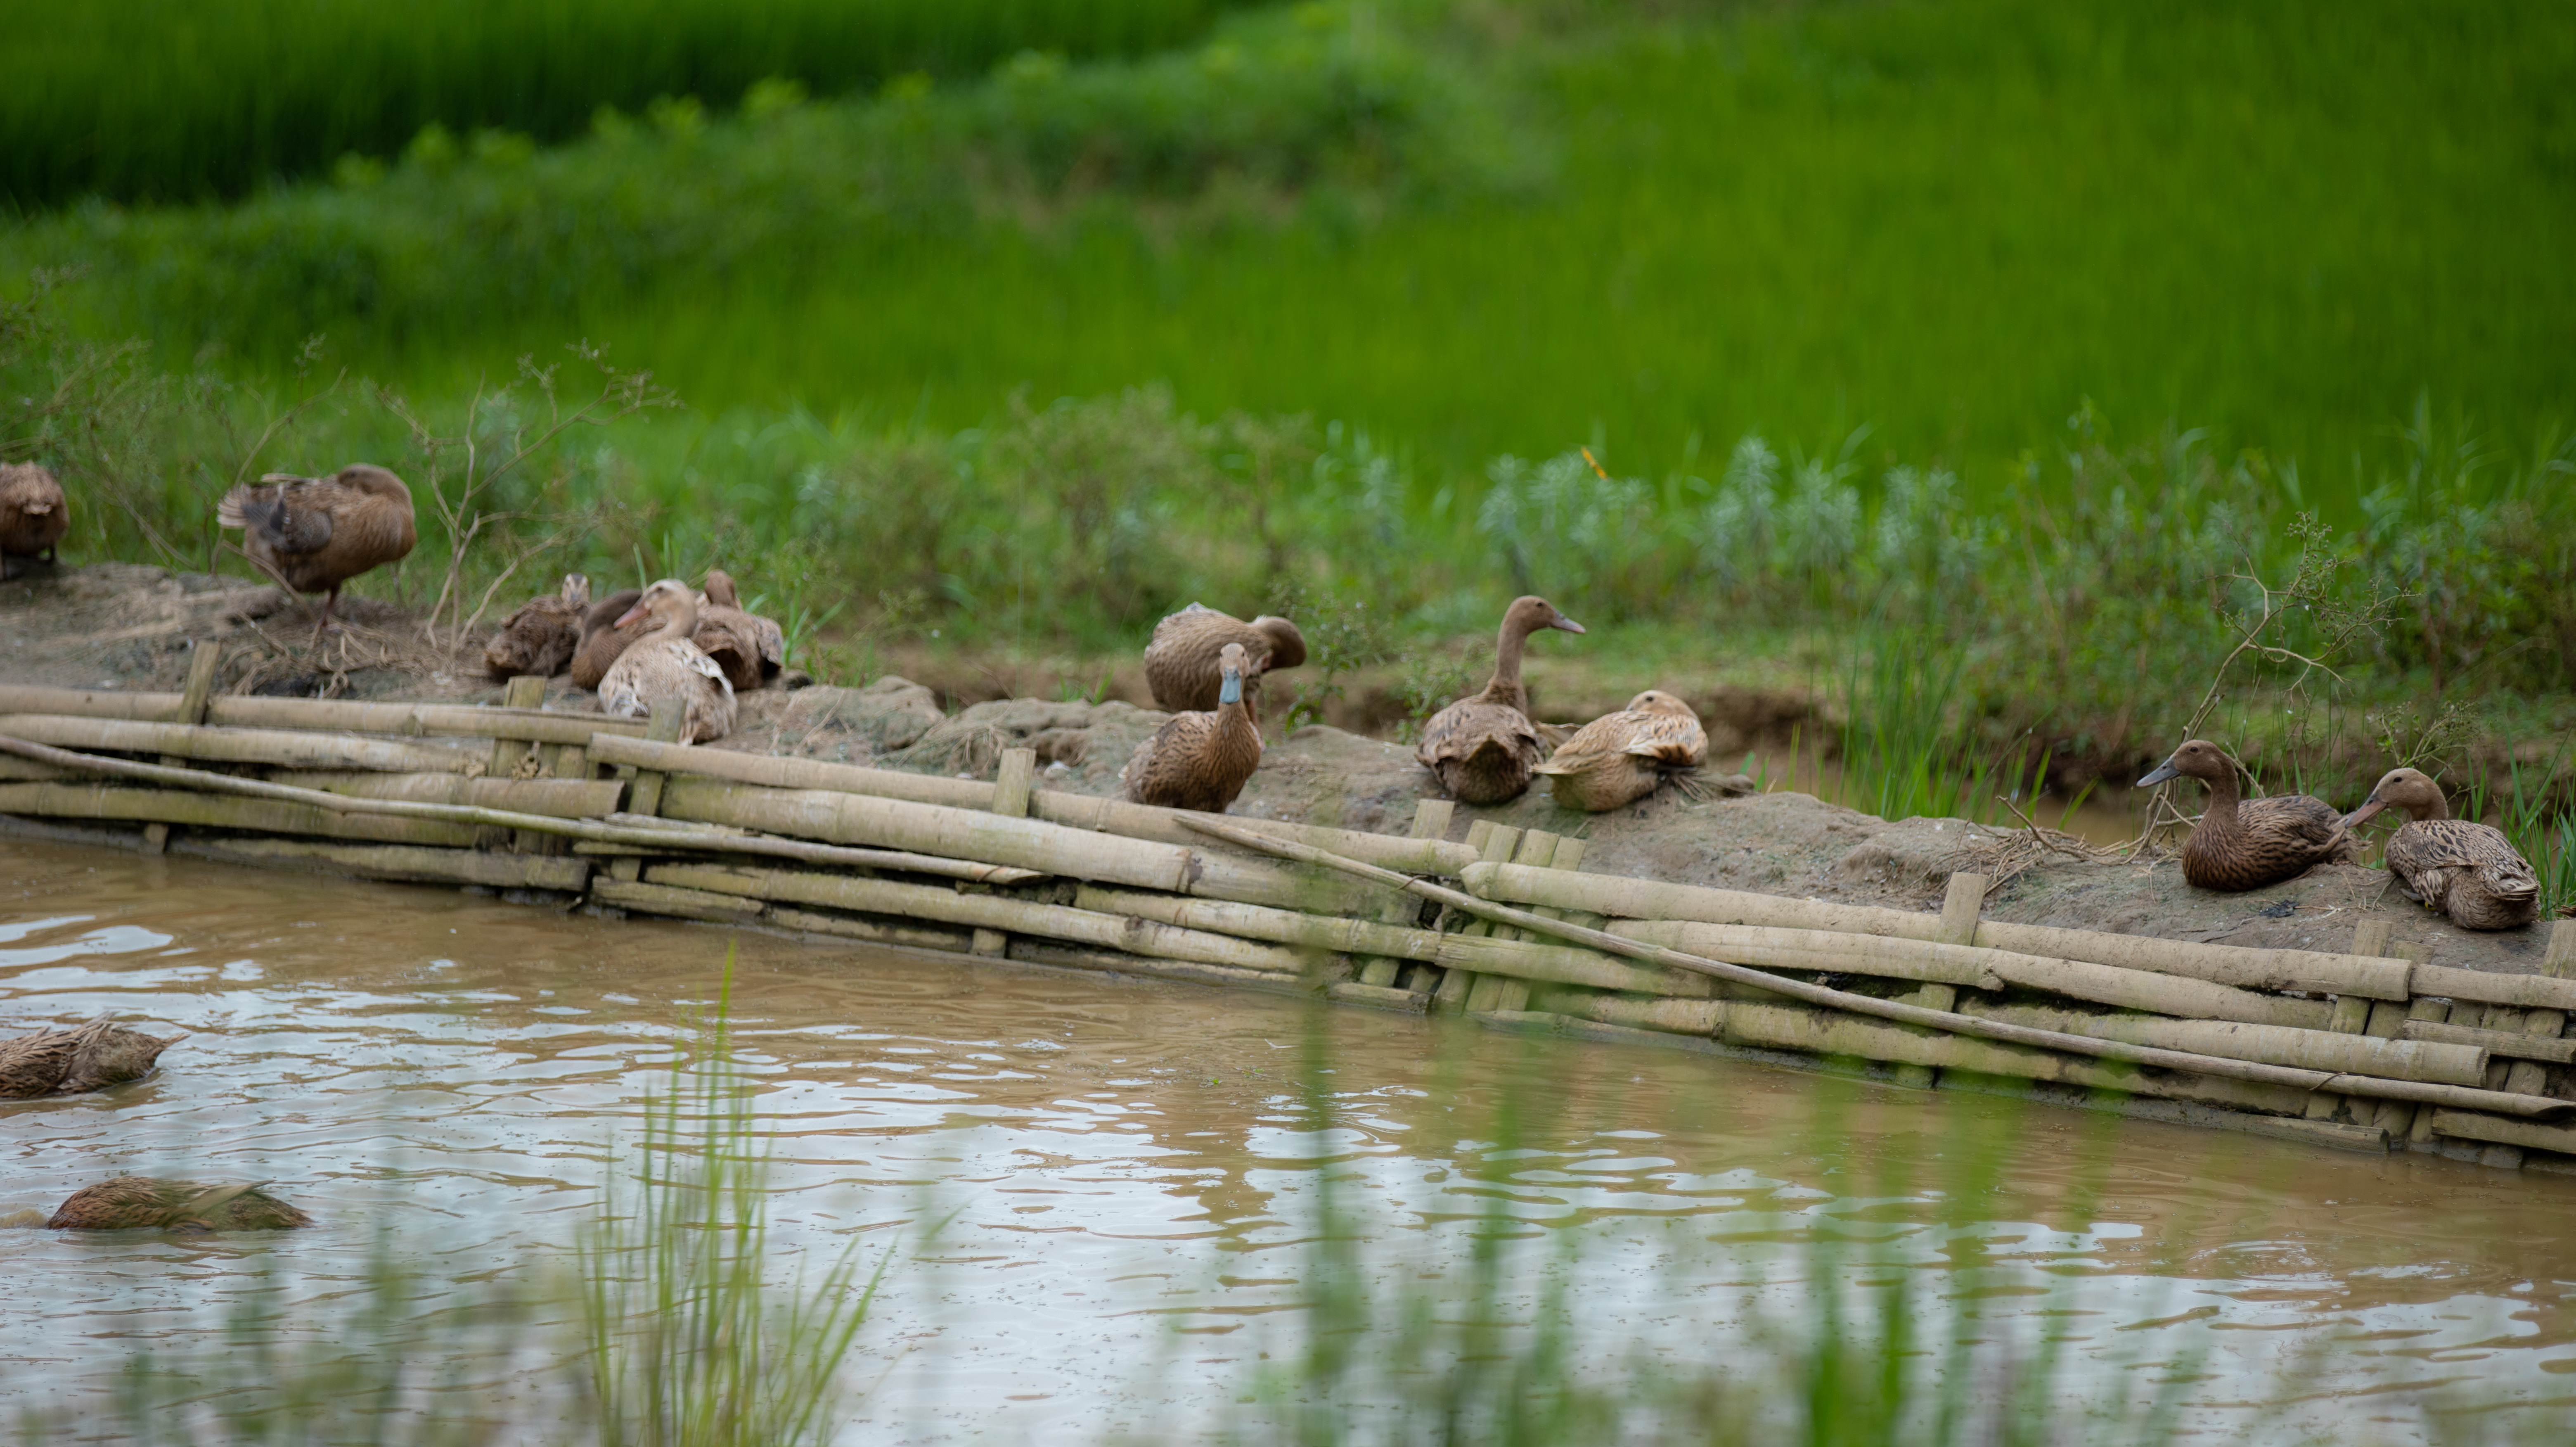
[0,564,2545,973]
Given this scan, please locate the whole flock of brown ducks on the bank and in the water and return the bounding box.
[0,453,2540,1228]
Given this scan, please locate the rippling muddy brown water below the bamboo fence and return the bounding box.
[0,844,2576,1442]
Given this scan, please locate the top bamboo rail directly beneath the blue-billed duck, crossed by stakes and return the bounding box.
[592,736,1476,875]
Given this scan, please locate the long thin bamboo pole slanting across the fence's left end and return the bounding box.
[0,734,1038,883]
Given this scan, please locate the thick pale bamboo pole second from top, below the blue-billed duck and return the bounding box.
[654,772,1360,911]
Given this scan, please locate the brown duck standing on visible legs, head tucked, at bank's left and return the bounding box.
[214,463,420,638]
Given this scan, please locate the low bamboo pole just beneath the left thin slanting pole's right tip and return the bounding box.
[644,865,1309,976]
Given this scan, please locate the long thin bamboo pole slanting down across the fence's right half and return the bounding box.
[1193,819,2576,1117]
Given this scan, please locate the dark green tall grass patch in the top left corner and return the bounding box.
[0,0,1247,209]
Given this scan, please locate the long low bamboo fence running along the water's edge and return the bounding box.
[0,646,2576,1169]
